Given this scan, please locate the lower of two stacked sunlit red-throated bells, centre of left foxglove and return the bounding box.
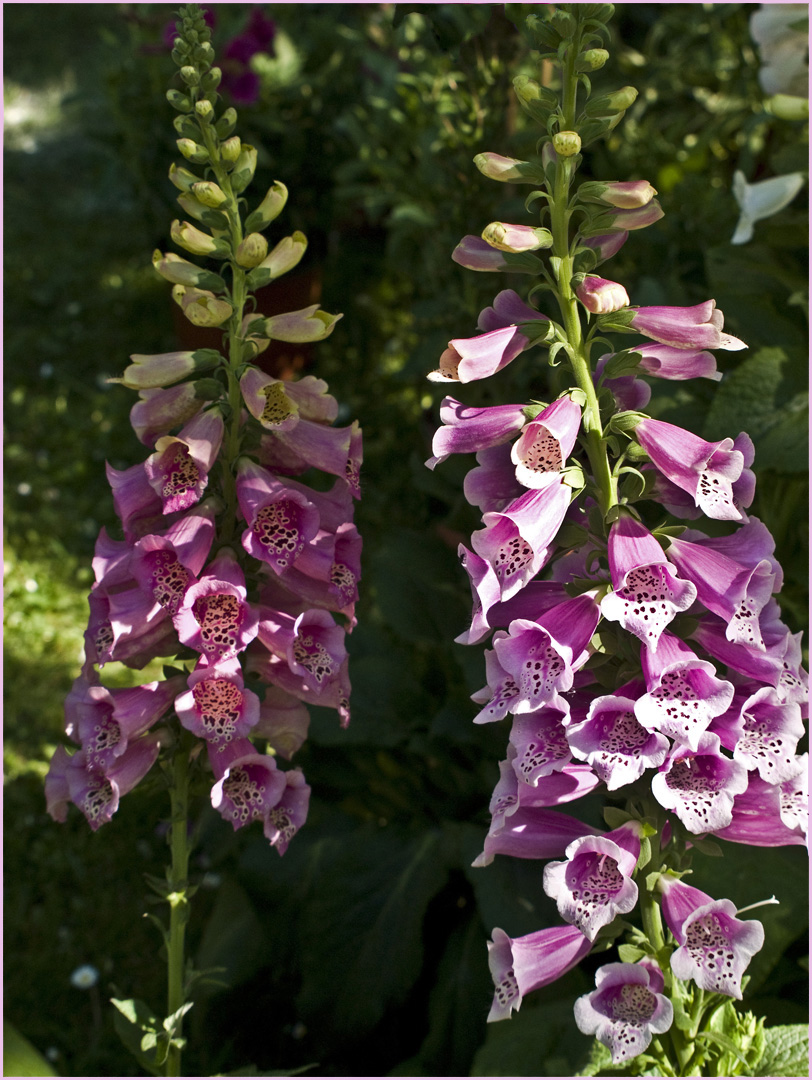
[175,657,259,756]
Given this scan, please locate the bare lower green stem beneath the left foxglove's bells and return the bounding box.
[165,737,189,1077]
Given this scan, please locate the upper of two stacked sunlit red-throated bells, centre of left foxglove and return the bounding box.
[173,548,259,664]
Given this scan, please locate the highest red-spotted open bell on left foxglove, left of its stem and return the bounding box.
[144,409,224,514]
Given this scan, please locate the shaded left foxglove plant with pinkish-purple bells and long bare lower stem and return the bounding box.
[45,4,362,1076]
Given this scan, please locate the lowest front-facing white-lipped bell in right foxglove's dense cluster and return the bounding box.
[651,731,747,835]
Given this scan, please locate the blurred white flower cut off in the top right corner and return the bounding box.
[750,3,809,97]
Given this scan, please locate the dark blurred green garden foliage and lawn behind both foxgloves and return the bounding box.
[3,3,808,1076]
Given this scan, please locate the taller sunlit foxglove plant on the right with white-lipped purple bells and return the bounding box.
[427,4,807,1076]
